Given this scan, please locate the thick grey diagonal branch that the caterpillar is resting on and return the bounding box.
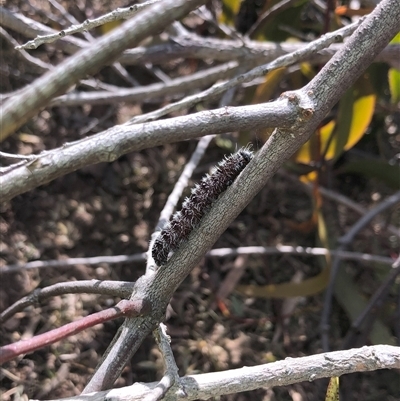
[84,0,400,394]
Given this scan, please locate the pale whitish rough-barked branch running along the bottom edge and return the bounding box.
[34,345,400,401]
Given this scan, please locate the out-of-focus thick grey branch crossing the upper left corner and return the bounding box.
[0,0,205,141]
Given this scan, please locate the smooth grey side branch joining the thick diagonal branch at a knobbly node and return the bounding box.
[0,100,296,202]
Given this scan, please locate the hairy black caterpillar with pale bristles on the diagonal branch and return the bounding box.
[152,148,253,266]
